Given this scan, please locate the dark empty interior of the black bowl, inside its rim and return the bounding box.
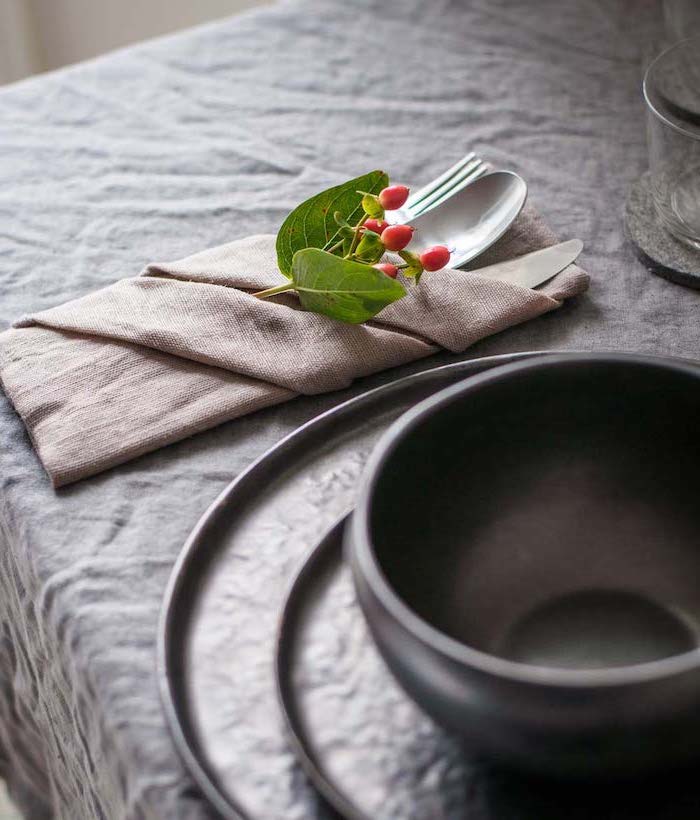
[369,359,700,669]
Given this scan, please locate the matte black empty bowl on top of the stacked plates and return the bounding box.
[346,354,700,776]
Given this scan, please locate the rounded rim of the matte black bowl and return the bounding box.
[350,353,700,688]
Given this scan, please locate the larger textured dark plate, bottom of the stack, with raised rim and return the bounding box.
[158,353,541,820]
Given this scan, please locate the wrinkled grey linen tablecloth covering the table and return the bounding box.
[0,0,700,820]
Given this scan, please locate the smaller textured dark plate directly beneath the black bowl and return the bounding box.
[277,521,700,820]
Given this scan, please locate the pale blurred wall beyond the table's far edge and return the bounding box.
[0,0,270,83]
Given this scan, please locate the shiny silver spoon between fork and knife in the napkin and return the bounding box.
[410,171,527,268]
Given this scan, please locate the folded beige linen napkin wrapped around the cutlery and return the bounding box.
[0,209,588,487]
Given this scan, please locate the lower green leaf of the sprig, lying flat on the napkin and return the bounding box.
[292,247,406,324]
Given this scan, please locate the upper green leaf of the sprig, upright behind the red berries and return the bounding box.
[277,171,389,279]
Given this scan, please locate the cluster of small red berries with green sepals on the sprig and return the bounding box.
[346,185,450,280]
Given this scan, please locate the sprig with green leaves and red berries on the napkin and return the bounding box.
[255,171,449,324]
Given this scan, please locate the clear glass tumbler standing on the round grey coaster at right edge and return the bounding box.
[644,37,700,250]
